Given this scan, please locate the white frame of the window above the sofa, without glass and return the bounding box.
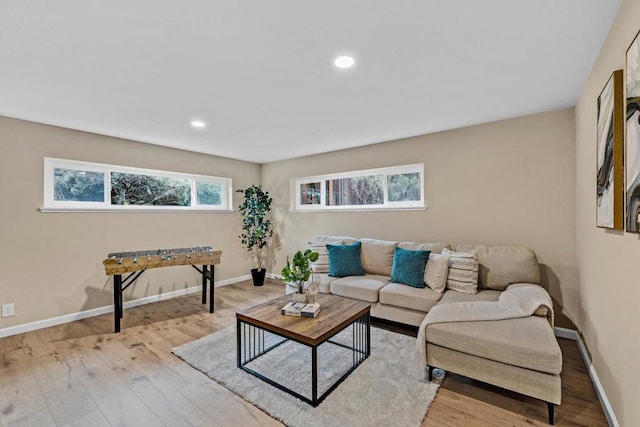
[291,163,427,212]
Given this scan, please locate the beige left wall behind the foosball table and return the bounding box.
[0,117,260,329]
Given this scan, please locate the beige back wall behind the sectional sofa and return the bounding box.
[262,109,578,319]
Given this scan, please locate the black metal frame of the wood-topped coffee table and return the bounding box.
[236,312,371,407]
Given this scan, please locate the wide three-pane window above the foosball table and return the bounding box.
[43,158,232,211]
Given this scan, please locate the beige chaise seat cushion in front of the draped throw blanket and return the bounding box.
[426,316,562,375]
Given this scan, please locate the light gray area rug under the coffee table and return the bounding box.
[173,325,438,427]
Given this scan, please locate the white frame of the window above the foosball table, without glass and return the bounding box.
[40,157,233,212]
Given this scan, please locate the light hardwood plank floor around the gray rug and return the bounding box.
[0,281,606,427]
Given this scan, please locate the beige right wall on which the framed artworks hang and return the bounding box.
[576,0,640,426]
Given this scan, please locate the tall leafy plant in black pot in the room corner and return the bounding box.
[237,185,273,286]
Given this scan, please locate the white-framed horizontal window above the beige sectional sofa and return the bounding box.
[294,164,425,210]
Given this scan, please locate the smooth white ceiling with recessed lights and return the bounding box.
[0,0,620,163]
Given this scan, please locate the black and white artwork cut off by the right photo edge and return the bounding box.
[626,33,640,233]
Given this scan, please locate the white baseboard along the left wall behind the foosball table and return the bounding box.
[0,274,251,338]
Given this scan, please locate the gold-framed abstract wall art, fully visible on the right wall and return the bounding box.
[596,70,624,230]
